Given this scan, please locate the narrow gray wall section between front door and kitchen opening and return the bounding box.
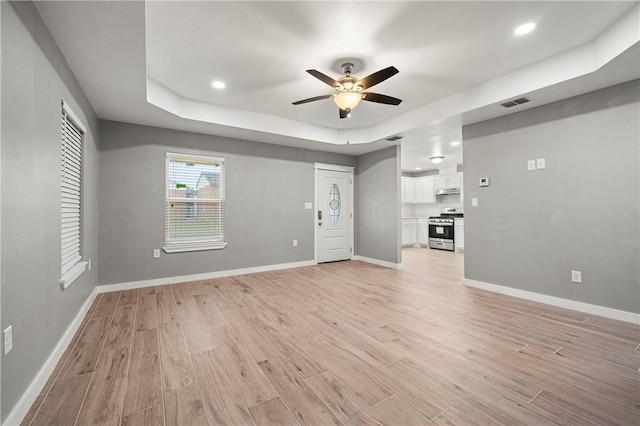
[355,146,402,264]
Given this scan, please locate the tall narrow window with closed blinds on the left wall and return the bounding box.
[60,101,87,289]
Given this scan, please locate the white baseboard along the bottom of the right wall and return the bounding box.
[464,278,640,324]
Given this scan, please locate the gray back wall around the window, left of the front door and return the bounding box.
[98,121,356,284]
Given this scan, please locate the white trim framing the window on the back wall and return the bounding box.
[162,152,227,254]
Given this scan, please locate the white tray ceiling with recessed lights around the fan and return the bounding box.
[36,1,640,171]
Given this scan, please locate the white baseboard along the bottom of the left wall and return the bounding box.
[3,289,98,425]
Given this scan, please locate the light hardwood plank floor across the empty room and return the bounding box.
[23,249,640,425]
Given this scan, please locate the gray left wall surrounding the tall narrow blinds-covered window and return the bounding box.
[0,1,98,421]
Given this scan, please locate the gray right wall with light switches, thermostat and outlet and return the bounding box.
[463,81,640,313]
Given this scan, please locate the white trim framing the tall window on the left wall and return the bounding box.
[59,100,89,290]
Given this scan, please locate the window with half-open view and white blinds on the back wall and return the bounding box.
[164,153,226,253]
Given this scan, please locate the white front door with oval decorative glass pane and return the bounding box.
[315,166,353,263]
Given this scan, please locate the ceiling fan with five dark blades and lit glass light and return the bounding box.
[293,62,402,118]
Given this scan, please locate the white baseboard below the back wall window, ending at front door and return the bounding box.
[96,260,317,293]
